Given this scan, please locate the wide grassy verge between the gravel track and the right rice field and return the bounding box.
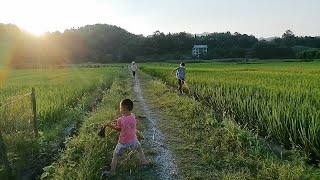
[144,74,320,180]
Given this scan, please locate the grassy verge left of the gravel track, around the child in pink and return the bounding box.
[41,76,157,179]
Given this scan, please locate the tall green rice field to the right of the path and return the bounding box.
[141,62,320,159]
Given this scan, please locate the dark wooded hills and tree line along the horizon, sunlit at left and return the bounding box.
[0,23,320,66]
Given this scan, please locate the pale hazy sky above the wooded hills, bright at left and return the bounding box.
[0,0,320,38]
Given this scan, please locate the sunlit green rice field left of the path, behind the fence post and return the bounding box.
[0,67,124,179]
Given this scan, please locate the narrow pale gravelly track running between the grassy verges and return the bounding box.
[133,76,179,180]
